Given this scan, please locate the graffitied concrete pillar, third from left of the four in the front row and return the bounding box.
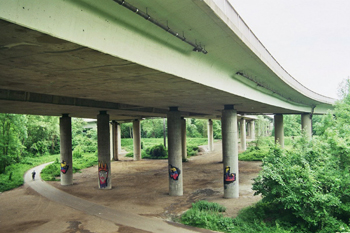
[167,107,183,196]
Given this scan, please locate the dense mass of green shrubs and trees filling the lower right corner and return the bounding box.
[183,80,350,233]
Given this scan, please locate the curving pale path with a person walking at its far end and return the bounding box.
[24,163,213,233]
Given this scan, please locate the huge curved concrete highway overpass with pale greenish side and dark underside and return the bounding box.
[0,0,334,197]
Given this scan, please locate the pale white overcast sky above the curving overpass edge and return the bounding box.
[229,0,350,98]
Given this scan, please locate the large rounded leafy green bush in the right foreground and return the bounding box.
[253,136,350,232]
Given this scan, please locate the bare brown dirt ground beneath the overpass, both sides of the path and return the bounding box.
[0,142,261,233]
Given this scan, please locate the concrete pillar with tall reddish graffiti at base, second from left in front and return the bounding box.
[97,111,112,189]
